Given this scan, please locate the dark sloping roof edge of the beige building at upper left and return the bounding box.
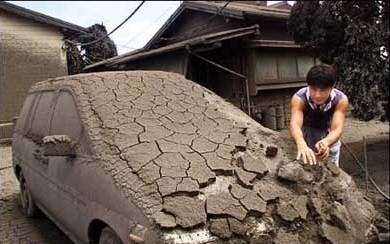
[0,2,89,33]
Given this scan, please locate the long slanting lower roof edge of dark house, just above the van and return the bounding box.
[84,25,259,70]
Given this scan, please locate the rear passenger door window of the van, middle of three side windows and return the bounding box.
[31,91,54,138]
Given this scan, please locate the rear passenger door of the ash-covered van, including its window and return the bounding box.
[21,91,55,210]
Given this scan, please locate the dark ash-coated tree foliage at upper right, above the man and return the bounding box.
[288,1,389,120]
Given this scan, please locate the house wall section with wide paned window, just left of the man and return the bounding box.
[247,47,319,129]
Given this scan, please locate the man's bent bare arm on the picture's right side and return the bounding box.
[316,97,349,152]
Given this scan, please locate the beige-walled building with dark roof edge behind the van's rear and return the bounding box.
[0,2,88,141]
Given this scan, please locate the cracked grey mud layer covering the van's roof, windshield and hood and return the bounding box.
[29,71,375,243]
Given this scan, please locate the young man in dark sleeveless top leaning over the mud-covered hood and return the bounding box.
[290,64,348,166]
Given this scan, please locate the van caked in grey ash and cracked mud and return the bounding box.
[12,71,375,244]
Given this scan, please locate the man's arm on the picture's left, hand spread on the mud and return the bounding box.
[290,95,317,164]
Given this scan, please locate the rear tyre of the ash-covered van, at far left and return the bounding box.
[19,172,38,218]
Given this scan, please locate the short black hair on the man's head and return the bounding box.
[306,64,336,89]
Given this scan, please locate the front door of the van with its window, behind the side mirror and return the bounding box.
[48,89,90,240]
